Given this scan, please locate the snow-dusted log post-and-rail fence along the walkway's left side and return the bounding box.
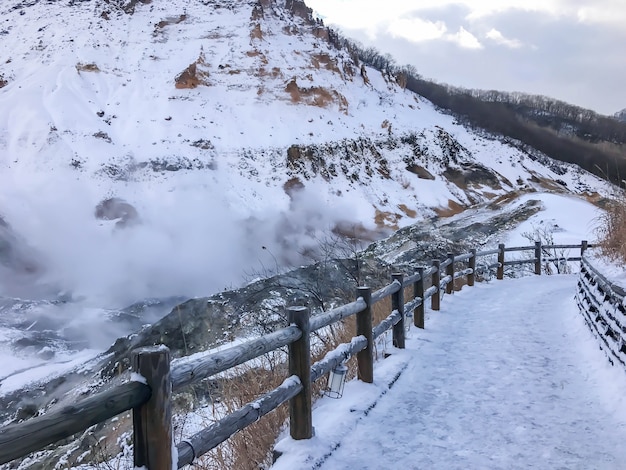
[0,241,588,470]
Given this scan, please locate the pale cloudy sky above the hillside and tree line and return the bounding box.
[306,0,626,114]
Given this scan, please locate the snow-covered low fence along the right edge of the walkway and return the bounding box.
[576,256,626,366]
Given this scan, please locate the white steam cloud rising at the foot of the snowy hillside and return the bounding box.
[0,171,373,307]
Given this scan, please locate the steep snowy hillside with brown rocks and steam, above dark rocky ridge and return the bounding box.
[0,0,598,302]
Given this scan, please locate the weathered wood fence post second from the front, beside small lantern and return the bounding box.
[287,307,313,440]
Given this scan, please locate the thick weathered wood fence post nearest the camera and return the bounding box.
[131,346,171,470]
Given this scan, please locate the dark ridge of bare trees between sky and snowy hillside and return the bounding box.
[329,30,626,185]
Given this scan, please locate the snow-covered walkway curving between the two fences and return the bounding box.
[272,276,626,470]
